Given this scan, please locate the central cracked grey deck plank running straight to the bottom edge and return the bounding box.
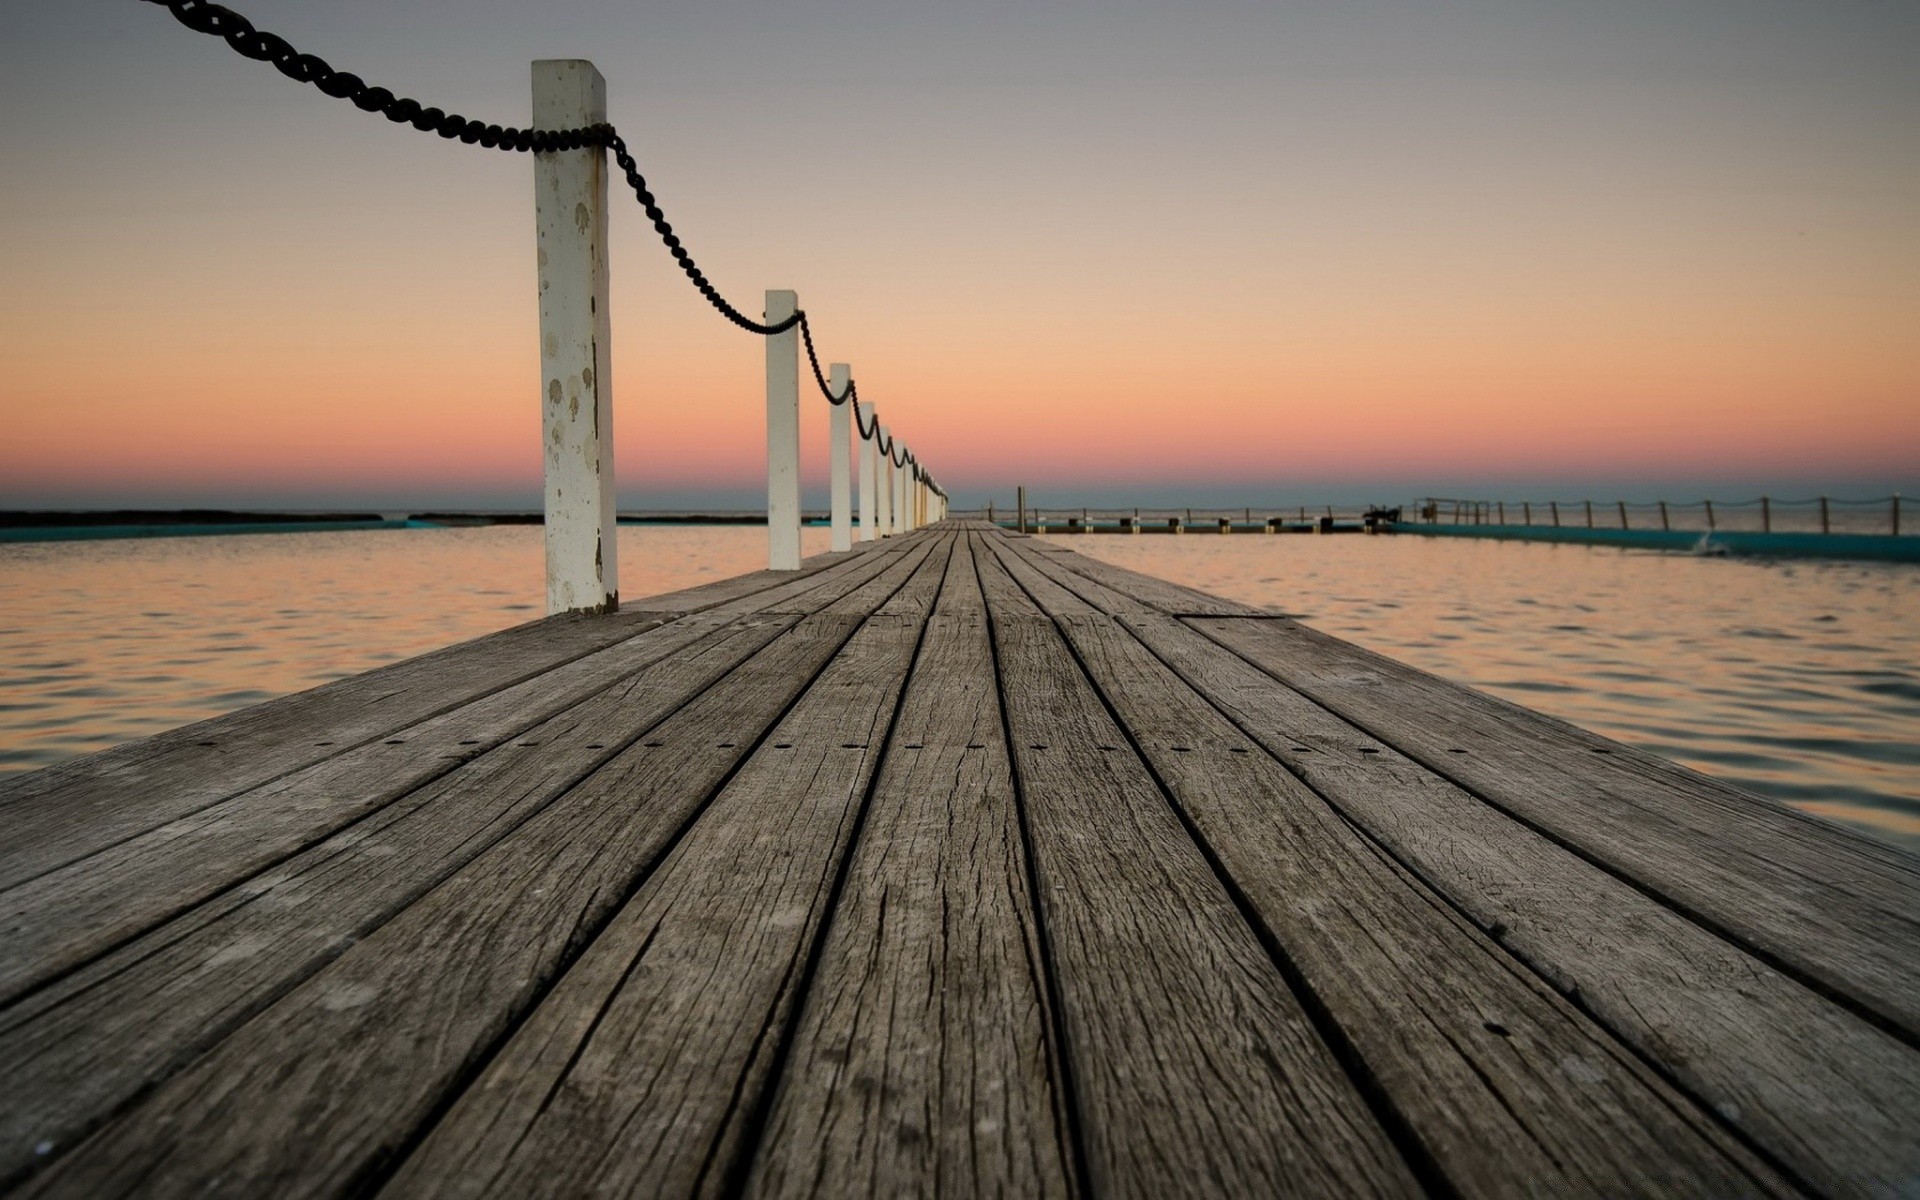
[745,547,1073,1196]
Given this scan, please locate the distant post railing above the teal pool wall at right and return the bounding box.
[1407,493,1912,538]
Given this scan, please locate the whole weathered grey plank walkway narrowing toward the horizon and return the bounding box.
[0,522,1920,1198]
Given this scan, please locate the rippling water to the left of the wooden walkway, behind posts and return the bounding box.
[0,526,828,774]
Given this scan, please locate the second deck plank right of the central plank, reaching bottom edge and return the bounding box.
[1000,547,1789,1196]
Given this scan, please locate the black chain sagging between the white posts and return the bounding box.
[144,0,945,495]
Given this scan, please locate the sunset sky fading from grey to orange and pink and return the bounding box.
[0,0,1920,509]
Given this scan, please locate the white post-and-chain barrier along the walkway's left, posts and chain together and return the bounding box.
[146,0,947,612]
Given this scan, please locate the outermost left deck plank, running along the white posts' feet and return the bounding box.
[0,533,898,887]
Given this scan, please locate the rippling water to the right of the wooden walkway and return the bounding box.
[1062,534,1920,849]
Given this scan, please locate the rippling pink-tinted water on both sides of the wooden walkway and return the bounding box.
[0,526,1920,849]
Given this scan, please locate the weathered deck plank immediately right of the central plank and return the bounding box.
[979,541,1419,1196]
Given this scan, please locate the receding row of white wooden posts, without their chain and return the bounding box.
[534,60,947,612]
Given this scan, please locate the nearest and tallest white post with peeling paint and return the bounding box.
[534,58,620,612]
